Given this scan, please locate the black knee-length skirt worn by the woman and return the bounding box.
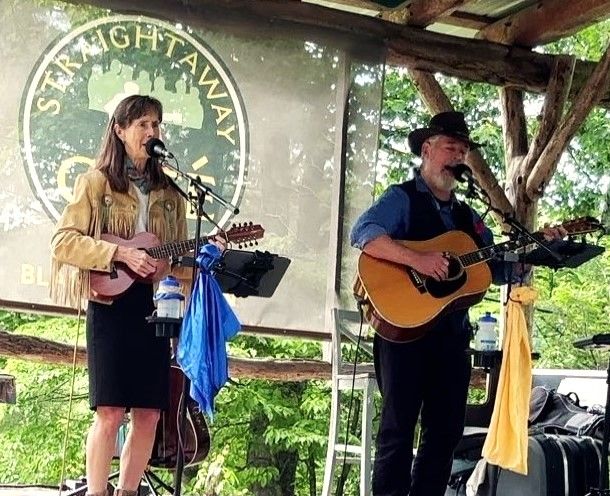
[87,283,170,410]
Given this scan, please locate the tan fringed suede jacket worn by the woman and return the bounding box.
[50,170,187,308]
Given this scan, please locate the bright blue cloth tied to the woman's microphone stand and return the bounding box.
[176,244,241,418]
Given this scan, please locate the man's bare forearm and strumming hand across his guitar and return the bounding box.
[363,235,449,281]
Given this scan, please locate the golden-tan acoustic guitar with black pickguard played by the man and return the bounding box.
[354,217,603,343]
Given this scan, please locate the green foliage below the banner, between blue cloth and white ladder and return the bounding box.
[180,336,340,495]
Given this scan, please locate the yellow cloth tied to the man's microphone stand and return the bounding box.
[483,286,538,475]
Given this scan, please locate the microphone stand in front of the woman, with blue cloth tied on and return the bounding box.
[162,160,239,496]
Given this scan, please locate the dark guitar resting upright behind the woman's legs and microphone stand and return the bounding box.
[150,365,211,469]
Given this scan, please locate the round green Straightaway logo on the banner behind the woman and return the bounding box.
[21,15,248,227]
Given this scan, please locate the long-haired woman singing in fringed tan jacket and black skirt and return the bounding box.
[51,95,187,496]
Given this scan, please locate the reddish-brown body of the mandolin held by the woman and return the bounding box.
[89,232,160,298]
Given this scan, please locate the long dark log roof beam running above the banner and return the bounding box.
[69,0,610,106]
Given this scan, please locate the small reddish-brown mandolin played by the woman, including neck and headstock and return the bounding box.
[89,223,265,299]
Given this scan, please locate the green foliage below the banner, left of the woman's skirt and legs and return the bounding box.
[0,312,90,484]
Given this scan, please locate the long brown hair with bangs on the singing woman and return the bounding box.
[95,95,169,193]
